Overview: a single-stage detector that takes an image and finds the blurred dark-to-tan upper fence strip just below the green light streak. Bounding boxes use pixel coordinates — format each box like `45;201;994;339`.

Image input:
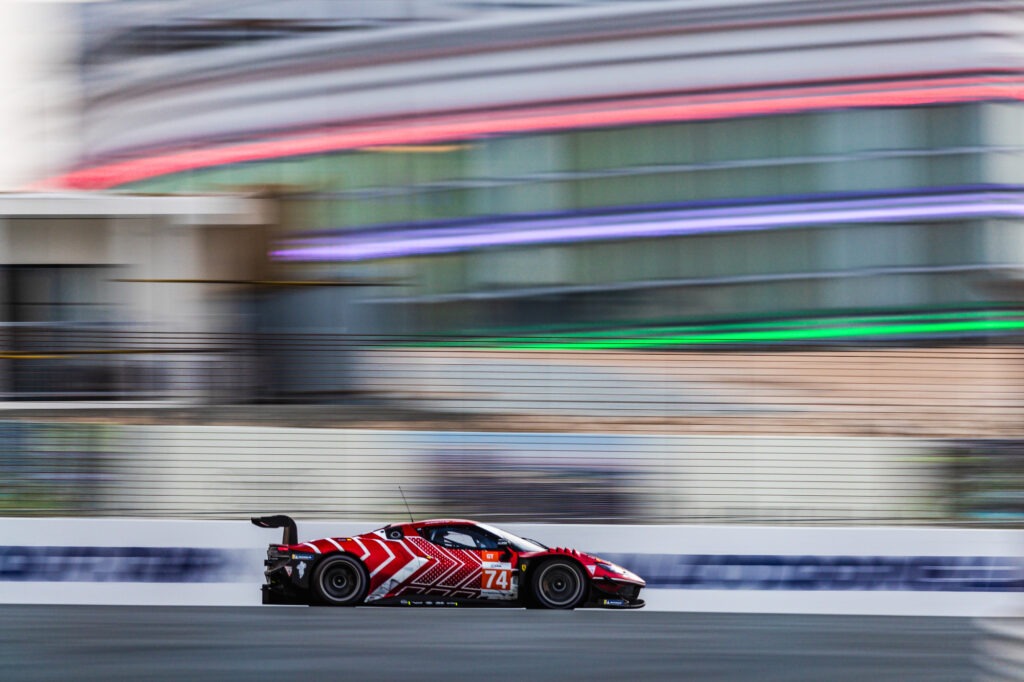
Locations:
0;330;1024;438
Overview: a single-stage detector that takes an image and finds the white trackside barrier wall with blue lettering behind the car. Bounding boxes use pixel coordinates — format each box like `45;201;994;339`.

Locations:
0;518;1024;616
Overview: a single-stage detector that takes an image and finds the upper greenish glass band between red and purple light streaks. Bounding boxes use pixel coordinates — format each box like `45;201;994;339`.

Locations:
124;103;987;223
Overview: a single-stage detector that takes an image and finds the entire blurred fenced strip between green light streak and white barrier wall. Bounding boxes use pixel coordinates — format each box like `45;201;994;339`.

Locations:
0;335;1024;524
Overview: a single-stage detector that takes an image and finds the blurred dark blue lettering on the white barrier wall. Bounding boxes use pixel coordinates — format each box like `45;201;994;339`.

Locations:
0;546;1024;592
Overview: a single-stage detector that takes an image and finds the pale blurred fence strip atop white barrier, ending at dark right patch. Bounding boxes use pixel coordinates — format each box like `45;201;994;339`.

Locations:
0;422;950;523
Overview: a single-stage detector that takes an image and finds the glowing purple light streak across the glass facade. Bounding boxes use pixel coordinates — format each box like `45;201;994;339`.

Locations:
271;191;1024;262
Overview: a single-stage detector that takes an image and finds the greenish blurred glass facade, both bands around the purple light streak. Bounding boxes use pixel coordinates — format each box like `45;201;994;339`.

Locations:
114;103;1024;332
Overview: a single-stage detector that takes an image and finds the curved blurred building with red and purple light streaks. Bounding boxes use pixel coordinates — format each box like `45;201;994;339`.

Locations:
48;0;1024;335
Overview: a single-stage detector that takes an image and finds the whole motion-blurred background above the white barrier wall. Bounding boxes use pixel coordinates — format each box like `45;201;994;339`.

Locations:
6;0;1024;525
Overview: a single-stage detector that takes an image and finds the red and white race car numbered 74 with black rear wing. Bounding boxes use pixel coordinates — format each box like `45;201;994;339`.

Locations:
252;515;645;608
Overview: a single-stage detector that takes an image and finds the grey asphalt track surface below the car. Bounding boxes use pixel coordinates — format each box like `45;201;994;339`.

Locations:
0;605;977;682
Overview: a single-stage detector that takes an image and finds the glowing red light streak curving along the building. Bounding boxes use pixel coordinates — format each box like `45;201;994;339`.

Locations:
36;77;1024;189
